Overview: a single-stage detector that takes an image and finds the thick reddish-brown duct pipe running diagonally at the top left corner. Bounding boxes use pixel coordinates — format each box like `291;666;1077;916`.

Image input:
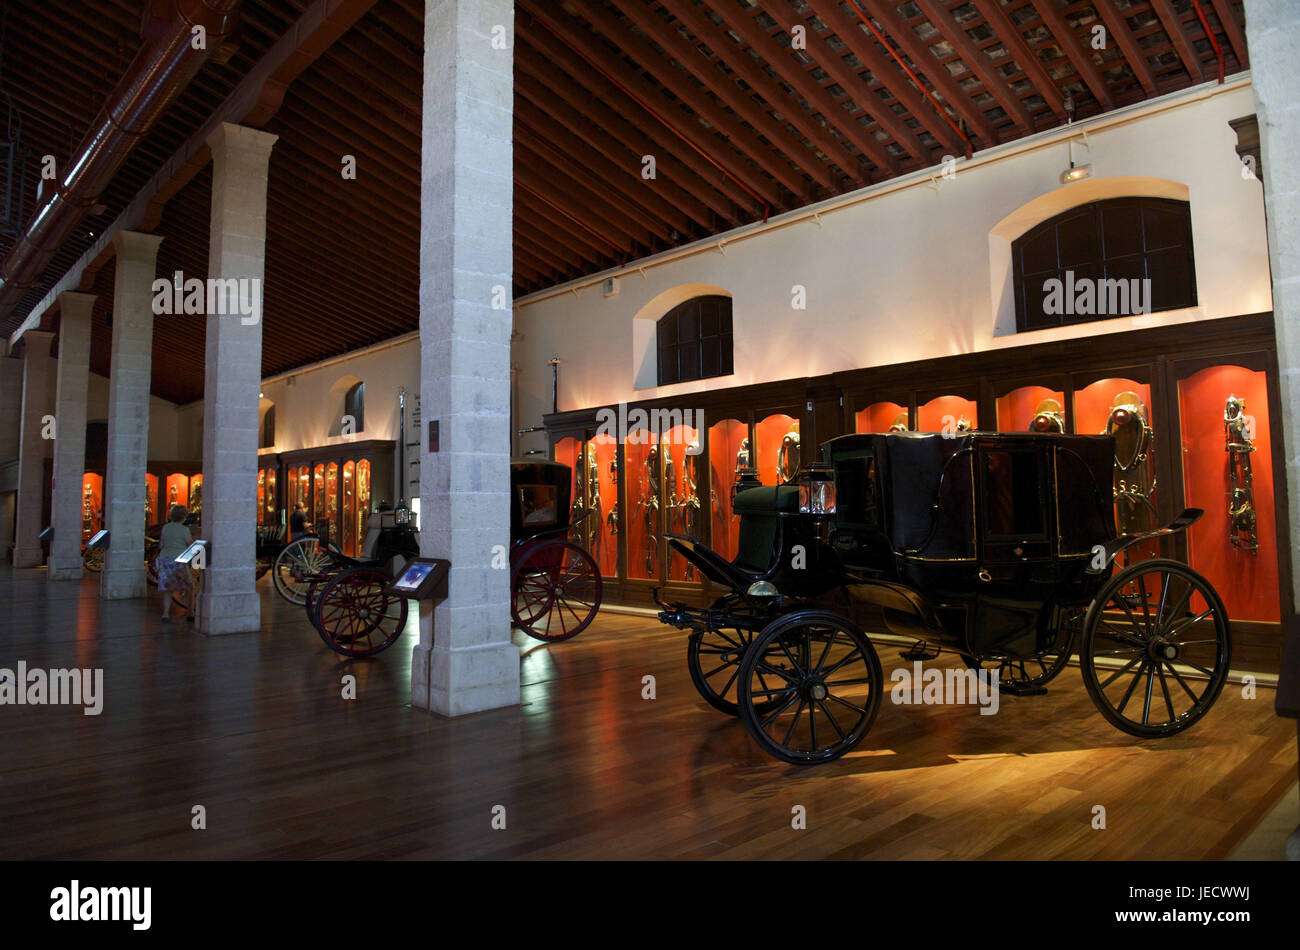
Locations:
0;0;241;318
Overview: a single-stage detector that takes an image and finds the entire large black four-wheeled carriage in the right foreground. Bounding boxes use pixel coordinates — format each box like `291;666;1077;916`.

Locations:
659;433;1231;764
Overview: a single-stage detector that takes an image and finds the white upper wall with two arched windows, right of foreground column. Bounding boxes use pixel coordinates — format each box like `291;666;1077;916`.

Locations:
514;79;1271;447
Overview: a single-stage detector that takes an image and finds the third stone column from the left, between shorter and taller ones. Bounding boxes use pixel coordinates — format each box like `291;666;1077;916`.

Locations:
99;231;162;600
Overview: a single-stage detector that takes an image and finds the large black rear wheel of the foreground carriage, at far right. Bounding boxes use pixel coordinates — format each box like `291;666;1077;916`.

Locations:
1079;560;1232;738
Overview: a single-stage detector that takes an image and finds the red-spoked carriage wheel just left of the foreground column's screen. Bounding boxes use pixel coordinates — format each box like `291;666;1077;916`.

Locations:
315;568;407;656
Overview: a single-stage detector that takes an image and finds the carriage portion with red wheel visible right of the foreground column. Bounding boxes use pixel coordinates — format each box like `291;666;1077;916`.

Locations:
510;459;602;642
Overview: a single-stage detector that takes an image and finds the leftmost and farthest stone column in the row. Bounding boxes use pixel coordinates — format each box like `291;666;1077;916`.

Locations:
13;330;55;568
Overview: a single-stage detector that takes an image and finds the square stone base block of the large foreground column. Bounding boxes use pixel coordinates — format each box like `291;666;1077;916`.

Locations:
411;641;519;716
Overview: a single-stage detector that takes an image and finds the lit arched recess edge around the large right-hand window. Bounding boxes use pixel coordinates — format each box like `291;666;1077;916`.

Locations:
988;175;1195;339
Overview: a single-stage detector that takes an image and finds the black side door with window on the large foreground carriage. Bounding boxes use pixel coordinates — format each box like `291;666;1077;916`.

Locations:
979;443;1065;581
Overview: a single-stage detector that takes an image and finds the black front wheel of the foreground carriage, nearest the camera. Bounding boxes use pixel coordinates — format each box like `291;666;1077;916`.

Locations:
737;611;884;765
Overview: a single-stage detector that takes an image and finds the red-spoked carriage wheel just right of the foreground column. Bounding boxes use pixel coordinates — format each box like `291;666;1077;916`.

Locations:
510;541;602;643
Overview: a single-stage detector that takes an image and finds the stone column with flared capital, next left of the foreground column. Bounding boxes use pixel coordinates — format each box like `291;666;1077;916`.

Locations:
199;122;277;634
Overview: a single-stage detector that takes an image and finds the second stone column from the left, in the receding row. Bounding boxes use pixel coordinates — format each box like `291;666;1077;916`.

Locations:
49;291;95;581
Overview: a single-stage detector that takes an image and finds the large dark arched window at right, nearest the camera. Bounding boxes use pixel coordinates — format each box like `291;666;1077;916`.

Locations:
1011;198;1196;331
